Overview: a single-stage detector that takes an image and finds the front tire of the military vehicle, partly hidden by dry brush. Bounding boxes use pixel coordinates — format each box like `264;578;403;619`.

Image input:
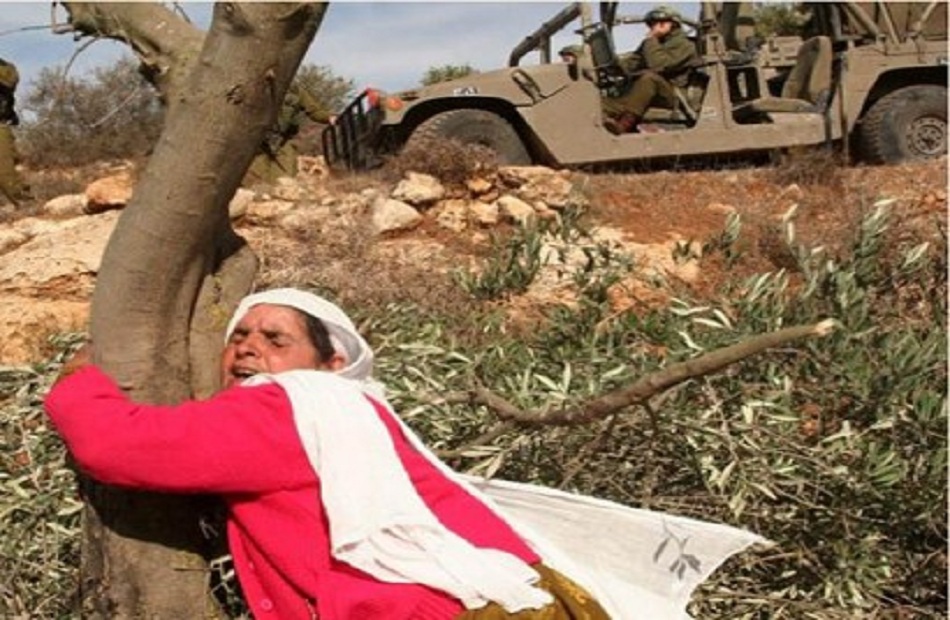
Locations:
409;110;531;166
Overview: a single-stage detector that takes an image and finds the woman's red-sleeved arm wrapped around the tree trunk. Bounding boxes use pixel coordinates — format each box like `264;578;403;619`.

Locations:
45;363;315;493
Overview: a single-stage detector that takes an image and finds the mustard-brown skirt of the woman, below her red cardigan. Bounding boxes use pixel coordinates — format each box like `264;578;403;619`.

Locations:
456;564;610;620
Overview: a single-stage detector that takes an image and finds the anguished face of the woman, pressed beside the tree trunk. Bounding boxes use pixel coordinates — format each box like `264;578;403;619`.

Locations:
221;304;339;388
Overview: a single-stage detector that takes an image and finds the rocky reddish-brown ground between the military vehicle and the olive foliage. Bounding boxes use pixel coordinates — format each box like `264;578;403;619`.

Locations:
0;155;947;366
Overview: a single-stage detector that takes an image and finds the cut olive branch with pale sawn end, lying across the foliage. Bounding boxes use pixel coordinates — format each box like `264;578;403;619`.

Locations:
442;319;835;432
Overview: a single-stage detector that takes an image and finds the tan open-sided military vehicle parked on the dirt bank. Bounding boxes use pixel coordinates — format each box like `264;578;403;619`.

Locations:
322;2;948;169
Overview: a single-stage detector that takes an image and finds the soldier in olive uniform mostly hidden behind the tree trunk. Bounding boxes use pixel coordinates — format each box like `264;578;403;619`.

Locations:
244;82;333;185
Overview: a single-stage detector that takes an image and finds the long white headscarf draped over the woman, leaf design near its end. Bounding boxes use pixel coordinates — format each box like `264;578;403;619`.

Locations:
227;289;766;620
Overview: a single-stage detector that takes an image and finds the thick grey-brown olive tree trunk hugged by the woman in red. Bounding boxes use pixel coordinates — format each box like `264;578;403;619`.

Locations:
57;3;327;619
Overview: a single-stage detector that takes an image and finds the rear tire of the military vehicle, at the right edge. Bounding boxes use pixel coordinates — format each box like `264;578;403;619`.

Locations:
859;85;947;164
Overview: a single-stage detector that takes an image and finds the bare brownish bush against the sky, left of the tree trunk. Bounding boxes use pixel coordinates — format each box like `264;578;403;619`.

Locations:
20;59;164;167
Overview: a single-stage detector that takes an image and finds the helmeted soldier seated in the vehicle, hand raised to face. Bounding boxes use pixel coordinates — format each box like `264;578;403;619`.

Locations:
603;6;699;134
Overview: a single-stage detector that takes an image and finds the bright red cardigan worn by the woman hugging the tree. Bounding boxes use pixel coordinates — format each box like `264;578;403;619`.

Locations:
45;366;538;620
